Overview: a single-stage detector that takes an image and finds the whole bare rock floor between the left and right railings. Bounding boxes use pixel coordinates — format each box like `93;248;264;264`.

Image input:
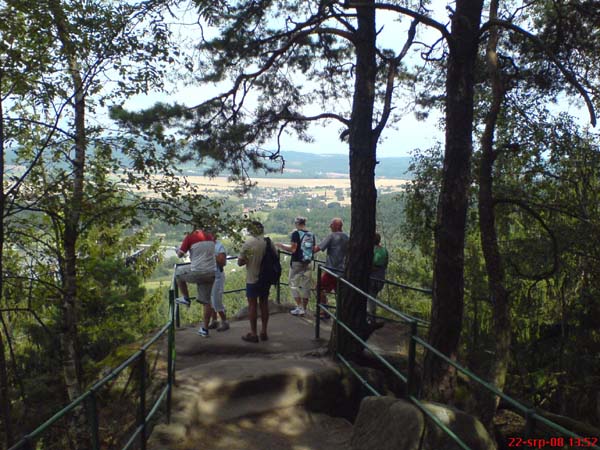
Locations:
148;305;352;450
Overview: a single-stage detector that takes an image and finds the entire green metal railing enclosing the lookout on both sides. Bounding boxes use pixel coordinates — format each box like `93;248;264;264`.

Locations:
14;251;600;450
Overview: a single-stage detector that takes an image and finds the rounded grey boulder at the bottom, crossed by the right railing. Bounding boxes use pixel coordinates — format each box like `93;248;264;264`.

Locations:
351;397;496;450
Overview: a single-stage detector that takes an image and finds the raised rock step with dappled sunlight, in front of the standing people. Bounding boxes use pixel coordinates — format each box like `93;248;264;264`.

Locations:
172;357;342;427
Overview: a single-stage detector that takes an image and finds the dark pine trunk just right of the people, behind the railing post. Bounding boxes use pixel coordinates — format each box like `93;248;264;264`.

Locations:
330;1;377;357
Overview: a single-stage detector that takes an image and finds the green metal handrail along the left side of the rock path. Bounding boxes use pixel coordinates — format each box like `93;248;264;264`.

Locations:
9;288;175;450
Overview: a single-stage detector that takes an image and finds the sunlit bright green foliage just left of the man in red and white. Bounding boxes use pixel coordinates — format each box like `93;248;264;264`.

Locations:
79;227;164;366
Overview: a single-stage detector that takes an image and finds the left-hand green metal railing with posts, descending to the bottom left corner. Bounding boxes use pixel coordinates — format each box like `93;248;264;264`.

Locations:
9;279;175;450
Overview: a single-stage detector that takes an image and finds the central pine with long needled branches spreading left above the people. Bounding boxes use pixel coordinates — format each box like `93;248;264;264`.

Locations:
116;0;417;355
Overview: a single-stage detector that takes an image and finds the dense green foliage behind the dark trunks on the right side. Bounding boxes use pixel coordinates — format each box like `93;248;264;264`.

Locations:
406;98;600;423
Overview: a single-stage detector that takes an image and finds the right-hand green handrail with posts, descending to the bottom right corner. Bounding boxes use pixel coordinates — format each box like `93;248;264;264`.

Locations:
315;265;600;450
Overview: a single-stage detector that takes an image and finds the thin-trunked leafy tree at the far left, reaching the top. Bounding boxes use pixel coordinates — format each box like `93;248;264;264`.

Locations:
0;0;185;443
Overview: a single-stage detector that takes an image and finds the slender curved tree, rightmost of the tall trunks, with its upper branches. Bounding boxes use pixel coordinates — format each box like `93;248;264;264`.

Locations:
478;2;595;425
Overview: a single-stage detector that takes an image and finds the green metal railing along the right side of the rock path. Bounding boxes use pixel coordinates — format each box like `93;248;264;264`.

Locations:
315;265;600;450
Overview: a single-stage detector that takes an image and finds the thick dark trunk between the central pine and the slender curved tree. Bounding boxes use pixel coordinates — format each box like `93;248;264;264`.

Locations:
424;0;483;400
